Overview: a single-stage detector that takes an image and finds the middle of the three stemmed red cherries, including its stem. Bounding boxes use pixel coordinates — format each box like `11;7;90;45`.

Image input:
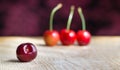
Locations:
60;6;76;45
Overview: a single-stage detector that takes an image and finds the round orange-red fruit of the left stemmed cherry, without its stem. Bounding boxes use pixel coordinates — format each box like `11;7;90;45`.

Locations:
43;30;60;46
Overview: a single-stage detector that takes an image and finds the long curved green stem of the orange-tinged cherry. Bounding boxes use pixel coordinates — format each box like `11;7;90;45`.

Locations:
49;3;62;31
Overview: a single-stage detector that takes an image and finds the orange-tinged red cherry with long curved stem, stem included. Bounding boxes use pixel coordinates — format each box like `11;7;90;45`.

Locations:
43;3;62;46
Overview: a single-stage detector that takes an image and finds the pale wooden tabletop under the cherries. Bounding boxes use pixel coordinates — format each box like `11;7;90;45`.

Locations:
0;36;120;70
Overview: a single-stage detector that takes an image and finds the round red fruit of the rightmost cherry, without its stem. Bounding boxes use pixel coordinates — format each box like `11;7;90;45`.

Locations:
77;30;91;46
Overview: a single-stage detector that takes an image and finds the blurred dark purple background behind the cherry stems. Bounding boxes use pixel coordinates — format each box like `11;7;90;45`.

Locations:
0;0;120;36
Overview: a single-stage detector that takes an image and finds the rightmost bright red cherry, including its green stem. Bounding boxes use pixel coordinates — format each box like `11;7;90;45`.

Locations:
77;7;91;45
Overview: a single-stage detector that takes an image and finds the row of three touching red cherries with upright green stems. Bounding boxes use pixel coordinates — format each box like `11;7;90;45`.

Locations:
43;3;91;46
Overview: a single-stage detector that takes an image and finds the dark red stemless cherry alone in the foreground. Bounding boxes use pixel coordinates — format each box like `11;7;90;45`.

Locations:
16;43;37;62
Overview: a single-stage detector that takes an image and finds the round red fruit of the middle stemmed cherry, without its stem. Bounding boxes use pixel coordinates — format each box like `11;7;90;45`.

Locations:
60;29;76;45
